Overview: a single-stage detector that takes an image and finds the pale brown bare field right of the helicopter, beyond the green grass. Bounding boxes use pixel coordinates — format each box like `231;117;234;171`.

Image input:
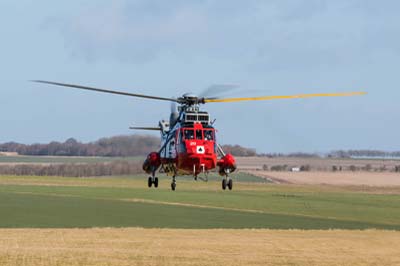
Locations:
237;157;400;187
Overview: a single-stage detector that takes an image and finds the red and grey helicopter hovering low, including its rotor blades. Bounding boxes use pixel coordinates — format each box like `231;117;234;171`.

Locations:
33;80;366;190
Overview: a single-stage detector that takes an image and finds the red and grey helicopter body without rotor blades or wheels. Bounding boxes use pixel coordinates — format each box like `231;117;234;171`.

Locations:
143;108;236;180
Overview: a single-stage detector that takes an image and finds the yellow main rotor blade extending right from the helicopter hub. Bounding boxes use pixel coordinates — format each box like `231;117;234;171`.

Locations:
204;92;367;103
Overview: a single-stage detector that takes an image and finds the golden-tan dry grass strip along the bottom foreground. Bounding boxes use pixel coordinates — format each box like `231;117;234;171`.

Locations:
0;228;400;266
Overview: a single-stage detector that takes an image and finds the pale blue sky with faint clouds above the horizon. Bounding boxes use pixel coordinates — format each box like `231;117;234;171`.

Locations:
0;0;400;152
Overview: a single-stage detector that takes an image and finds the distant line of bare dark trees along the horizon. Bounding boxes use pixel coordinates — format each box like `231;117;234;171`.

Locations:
0;135;400;158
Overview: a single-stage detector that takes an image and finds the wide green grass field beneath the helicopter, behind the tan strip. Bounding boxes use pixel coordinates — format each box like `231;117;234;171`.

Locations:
0;175;400;230
